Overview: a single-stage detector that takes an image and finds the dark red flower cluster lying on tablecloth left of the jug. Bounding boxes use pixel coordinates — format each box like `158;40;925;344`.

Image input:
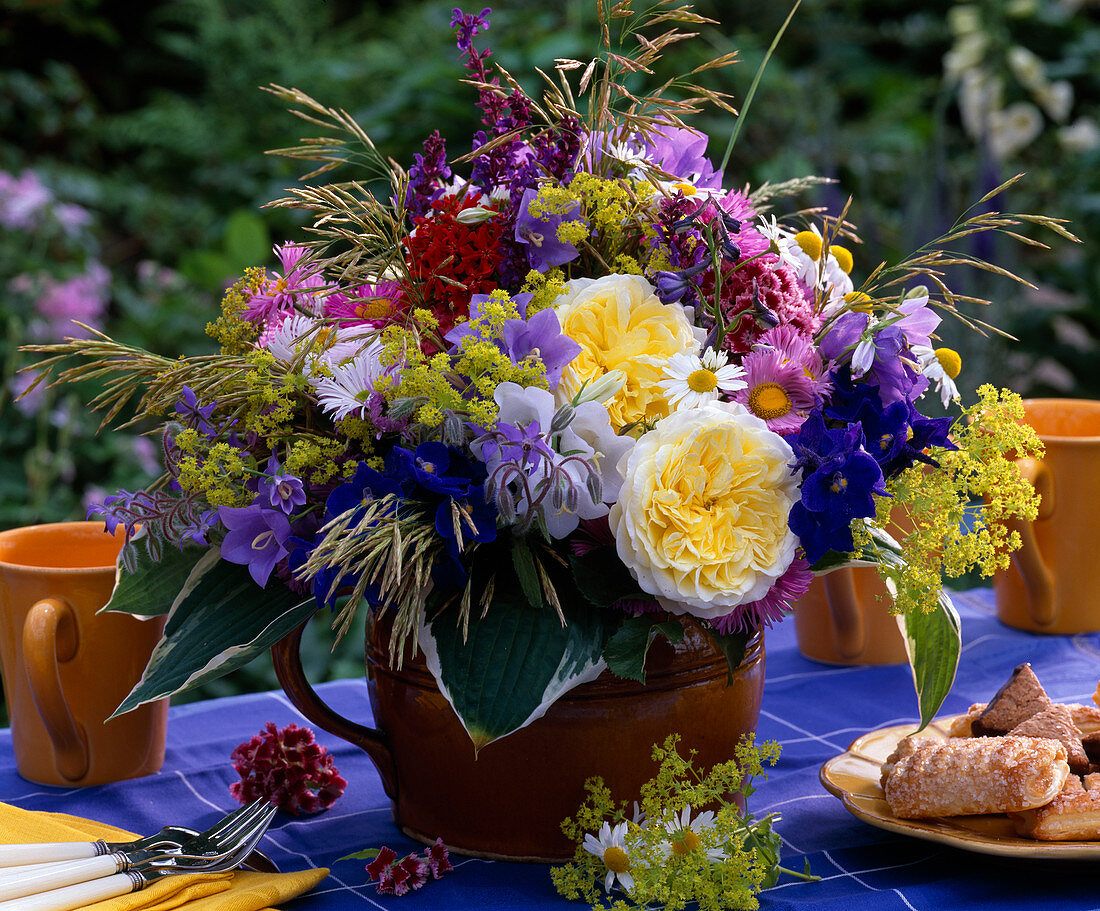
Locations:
229;722;348;816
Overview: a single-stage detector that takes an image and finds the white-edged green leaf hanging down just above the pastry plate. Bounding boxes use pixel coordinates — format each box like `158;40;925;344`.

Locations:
887;581;963;731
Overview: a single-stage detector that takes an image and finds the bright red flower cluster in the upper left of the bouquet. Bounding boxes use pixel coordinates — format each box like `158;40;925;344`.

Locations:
405;194;504;334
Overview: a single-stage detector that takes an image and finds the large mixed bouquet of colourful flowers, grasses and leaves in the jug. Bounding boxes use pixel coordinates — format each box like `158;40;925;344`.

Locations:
30;2;1066;862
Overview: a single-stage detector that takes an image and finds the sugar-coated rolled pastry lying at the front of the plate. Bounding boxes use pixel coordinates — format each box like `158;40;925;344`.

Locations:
881;737;1069;820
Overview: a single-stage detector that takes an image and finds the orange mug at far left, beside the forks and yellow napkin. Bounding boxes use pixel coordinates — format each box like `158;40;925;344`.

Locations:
0;522;168;787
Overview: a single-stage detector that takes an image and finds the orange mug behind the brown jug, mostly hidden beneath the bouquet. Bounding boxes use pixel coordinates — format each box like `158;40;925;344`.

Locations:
794;567;908;665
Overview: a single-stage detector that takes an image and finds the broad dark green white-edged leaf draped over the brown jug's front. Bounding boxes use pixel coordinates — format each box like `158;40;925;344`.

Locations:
420;585;605;750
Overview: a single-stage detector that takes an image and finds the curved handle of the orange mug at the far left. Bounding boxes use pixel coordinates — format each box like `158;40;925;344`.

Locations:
23;597;90;781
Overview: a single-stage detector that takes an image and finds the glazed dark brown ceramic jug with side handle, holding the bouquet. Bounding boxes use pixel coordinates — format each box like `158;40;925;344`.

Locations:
273;623;765;861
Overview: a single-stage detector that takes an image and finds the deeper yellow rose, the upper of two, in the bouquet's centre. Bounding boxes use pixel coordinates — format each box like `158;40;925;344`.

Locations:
556;275;702;430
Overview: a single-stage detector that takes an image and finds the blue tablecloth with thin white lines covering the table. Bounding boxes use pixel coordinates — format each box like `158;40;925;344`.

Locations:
0;590;1100;911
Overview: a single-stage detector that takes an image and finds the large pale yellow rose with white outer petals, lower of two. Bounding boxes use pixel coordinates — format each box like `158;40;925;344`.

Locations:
608;403;799;618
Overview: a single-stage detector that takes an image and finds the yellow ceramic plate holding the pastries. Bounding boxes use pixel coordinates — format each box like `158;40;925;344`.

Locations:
821;716;1100;860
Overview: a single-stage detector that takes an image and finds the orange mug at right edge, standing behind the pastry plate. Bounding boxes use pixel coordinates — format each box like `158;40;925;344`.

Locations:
993;398;1100;634
